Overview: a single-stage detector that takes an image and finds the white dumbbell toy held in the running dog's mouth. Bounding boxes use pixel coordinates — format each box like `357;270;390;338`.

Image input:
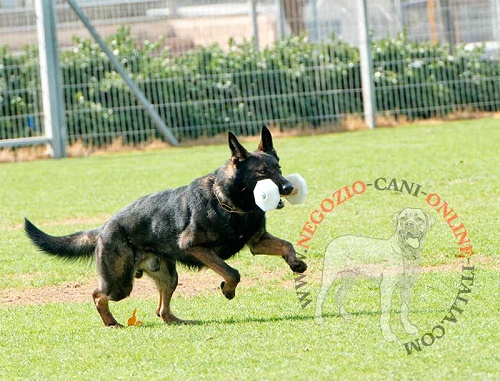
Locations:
253;173;307;212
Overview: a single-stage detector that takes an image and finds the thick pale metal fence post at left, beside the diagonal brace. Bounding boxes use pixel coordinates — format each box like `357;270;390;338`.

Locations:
35;0;66;158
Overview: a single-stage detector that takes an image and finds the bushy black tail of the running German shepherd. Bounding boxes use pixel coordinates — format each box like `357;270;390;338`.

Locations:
24;218;100;260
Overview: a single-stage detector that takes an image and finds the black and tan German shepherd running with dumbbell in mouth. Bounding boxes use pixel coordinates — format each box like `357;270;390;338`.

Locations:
25;126;307;327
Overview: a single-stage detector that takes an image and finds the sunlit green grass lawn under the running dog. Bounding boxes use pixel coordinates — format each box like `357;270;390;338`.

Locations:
0;119;500;380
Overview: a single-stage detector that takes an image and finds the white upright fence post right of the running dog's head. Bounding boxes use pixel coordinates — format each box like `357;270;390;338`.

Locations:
357;0;376;128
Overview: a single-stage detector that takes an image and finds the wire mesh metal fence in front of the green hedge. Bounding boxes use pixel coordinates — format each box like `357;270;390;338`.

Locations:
0;0;500;154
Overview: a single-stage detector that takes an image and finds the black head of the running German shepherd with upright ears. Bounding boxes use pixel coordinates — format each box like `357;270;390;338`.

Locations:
228;126;293;208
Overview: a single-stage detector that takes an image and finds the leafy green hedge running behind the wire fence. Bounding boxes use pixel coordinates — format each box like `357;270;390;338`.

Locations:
0;27;500;145
